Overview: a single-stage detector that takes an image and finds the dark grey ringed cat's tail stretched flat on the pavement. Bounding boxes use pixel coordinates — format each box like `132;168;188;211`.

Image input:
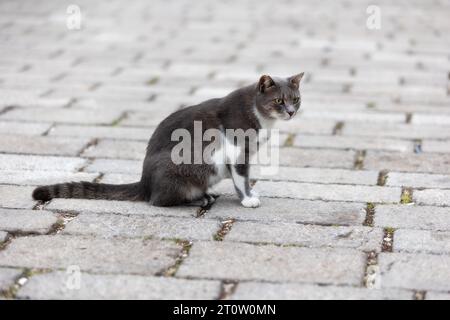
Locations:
33;181;145;201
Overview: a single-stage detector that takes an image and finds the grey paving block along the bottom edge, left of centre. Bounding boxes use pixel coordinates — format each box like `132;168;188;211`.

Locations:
17;272;220;300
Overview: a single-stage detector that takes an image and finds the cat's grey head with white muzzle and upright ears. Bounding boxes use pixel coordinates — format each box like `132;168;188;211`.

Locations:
256;72;304;120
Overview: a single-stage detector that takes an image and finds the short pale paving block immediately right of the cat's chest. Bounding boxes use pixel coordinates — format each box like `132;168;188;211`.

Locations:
279;148;356;169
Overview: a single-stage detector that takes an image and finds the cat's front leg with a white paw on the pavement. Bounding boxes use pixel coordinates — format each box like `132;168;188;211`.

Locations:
230;164;261;208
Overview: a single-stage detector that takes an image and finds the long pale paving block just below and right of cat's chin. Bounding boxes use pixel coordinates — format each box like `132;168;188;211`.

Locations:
294;135;414;152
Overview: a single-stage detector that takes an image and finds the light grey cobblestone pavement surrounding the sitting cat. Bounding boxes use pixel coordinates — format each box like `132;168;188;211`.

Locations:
0;0;450;299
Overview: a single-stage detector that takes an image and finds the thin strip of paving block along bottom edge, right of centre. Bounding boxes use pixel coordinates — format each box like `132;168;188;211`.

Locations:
231;282;413;300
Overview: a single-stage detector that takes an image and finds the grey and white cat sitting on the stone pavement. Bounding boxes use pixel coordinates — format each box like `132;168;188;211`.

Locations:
32;72;304;208
